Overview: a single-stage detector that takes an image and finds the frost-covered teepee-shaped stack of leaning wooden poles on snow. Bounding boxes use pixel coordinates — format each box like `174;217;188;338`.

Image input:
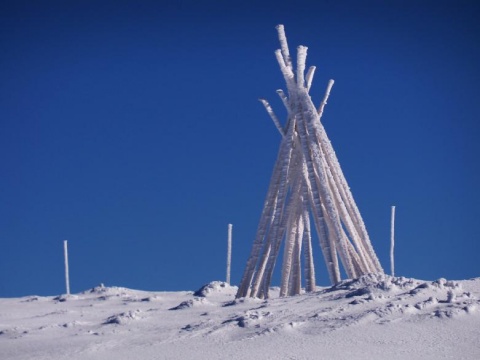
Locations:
237;25;383;298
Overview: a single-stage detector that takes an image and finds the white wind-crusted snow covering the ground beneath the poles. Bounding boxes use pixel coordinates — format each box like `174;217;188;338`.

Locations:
0;275;480;360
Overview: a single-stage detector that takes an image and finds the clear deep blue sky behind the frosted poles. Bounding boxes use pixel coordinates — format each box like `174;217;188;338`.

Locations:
0;1;480;297
